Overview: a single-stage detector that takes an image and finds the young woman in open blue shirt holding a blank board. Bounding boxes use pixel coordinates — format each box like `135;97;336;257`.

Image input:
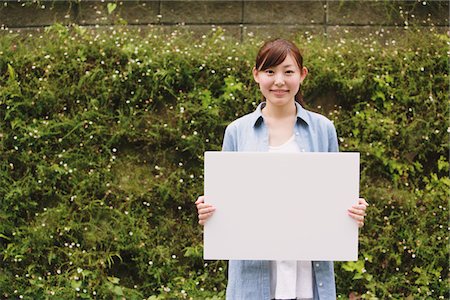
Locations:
195;39;368;300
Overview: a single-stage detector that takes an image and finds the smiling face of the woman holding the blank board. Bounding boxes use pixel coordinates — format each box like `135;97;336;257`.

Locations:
253;54;308;106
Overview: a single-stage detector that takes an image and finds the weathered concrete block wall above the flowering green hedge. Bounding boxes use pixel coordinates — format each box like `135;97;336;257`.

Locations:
0;0;449;40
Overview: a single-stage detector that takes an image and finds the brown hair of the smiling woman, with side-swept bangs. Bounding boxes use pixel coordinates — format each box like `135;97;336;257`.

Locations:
255;39;305;107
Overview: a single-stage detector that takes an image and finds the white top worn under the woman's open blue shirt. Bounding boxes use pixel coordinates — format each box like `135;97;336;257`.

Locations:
269;135;313;299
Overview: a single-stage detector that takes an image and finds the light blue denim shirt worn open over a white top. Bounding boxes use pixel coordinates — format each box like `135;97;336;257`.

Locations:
222;102;338;300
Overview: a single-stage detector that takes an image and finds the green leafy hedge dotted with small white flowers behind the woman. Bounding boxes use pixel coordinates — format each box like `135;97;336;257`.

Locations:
0;25;450;299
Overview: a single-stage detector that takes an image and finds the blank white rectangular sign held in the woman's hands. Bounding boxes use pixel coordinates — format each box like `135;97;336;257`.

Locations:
204;151;359;261
